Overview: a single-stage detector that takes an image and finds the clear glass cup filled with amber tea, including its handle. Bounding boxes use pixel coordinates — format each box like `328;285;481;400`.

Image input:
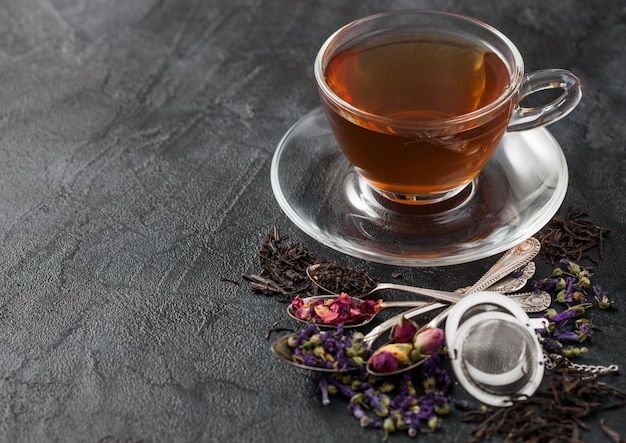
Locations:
314;10;582;205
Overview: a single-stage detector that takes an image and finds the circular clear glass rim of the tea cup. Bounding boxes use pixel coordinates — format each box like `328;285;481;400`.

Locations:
314;9;524;131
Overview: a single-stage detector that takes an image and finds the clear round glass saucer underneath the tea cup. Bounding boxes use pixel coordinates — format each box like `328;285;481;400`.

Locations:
271;108;568;267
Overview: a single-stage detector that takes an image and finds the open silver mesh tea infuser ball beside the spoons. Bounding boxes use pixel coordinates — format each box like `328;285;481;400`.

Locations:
445;292;547;406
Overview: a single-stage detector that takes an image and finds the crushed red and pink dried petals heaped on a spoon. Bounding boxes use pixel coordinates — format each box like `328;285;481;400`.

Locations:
291;292;383;326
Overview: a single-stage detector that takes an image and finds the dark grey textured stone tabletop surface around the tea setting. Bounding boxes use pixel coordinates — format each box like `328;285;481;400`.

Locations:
0;0;626;442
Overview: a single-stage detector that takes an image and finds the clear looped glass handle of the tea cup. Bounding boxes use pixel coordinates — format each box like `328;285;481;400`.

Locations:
507;69;583;132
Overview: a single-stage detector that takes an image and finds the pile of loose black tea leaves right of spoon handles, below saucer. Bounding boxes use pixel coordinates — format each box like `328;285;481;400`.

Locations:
537;208;609;265
